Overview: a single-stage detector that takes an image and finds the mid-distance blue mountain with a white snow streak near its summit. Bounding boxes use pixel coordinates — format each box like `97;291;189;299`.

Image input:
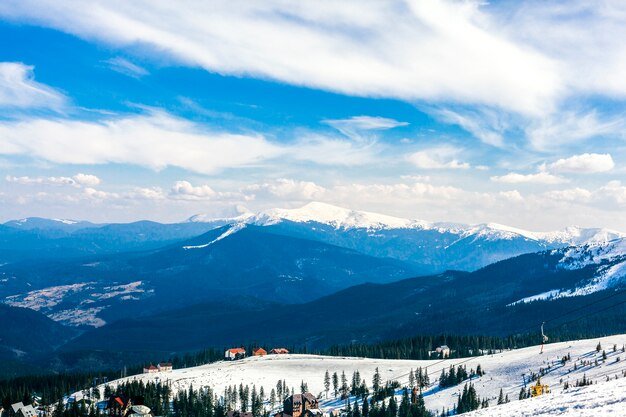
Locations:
0;225;419;326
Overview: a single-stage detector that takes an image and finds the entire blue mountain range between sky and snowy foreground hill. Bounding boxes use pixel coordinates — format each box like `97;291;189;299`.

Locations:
0;203;626;370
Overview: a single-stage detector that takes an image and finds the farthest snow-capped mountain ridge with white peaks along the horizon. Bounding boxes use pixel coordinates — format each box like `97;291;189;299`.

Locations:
191;202;626;273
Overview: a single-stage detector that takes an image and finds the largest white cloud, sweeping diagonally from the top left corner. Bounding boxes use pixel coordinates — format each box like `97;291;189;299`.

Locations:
0;0;561;114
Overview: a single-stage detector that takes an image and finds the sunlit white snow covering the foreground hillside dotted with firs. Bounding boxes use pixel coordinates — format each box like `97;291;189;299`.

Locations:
86;329;626;416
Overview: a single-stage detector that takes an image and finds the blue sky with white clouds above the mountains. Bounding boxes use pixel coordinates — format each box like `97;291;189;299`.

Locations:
0;0;626;231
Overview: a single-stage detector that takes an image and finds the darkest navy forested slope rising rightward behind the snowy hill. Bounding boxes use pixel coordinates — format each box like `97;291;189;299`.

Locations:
64;239;626;351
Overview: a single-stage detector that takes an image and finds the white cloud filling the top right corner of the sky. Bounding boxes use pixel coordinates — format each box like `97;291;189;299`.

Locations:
500;0;626;98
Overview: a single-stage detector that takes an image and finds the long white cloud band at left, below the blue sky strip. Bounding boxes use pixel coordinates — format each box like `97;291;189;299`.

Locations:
0;112;286;173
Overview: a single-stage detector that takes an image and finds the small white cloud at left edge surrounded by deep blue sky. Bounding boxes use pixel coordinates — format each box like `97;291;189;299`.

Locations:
0;62;66;110
